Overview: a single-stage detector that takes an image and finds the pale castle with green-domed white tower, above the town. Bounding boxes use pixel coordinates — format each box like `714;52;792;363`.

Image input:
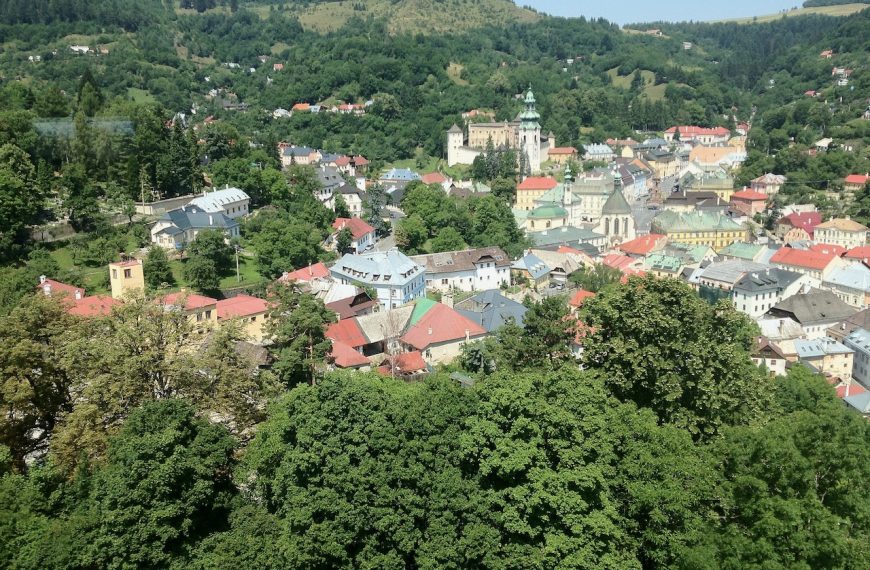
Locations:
447;87;556;175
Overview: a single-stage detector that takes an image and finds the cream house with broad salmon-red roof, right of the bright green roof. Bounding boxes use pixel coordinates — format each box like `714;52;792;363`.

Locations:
400;303;487;364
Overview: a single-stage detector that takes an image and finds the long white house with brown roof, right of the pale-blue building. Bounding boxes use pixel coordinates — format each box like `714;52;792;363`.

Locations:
411;246;511;293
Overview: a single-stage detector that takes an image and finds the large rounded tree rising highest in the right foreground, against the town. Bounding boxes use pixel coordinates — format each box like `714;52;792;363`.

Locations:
581;277;771;439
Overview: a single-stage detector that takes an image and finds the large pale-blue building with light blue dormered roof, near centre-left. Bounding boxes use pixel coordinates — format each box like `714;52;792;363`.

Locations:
329;249;426;310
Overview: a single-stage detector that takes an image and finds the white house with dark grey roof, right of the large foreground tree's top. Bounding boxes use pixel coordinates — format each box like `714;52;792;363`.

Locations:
731;267;811;319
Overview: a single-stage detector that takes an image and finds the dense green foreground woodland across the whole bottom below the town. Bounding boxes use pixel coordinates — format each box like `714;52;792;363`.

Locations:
0;277;870;569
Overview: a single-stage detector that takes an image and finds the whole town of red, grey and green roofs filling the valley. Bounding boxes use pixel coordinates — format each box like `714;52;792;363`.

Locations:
30;85;870;415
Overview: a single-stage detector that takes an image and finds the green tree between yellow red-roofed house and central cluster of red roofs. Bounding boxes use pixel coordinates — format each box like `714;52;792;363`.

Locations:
266;285;335;387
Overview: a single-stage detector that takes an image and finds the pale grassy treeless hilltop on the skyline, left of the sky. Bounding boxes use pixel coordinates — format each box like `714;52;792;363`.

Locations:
242;0;541;34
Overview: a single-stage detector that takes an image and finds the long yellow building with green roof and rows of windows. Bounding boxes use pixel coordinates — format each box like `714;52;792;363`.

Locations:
651;210;747;251
